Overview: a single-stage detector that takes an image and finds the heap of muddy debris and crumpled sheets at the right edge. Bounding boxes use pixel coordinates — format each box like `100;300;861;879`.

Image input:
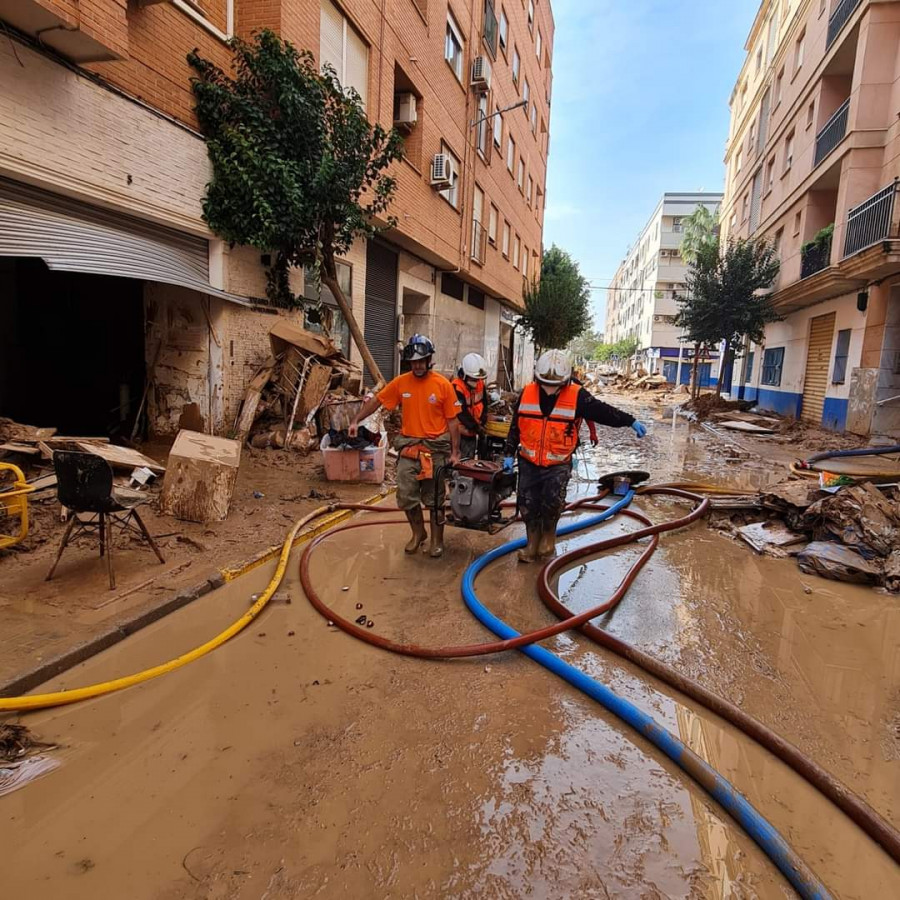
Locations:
709;479;900;593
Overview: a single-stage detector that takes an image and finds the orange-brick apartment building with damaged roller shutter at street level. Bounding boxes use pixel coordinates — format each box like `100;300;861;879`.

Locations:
0;0;554;434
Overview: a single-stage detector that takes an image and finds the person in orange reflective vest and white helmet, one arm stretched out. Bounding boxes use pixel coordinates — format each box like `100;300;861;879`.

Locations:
503;350;647;562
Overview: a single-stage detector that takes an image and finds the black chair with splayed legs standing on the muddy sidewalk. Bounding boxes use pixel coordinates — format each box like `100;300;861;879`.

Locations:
47;450;165;590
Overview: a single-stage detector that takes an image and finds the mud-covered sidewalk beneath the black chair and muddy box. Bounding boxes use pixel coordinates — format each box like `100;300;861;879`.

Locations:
0;448;381;696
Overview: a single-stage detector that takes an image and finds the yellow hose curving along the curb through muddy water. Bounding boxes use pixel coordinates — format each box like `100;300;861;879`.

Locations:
0;506;334;712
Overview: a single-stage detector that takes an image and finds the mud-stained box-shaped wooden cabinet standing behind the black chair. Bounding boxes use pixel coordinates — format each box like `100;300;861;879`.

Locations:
160;431;241;522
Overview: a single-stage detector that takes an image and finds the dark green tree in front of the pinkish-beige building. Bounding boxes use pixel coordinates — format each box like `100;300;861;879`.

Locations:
676;238;783;393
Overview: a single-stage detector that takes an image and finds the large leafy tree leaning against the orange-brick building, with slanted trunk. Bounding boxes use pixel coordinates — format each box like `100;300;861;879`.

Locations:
188;30;401;381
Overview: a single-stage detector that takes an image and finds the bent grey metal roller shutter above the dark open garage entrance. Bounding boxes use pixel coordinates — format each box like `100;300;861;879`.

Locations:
0;179;252;306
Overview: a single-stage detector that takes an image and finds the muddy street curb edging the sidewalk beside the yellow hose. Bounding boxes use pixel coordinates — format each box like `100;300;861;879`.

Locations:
0;490;393;697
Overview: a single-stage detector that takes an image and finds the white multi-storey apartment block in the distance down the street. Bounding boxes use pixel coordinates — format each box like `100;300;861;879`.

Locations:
605;193;722;386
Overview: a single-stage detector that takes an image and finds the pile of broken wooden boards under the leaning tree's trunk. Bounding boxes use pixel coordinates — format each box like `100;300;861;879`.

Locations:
233;322;363;454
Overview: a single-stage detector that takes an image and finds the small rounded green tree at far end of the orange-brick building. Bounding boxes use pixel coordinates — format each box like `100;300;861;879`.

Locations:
517;250;591;351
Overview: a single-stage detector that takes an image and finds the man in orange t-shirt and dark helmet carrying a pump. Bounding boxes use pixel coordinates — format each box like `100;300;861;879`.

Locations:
348;334;461;558
